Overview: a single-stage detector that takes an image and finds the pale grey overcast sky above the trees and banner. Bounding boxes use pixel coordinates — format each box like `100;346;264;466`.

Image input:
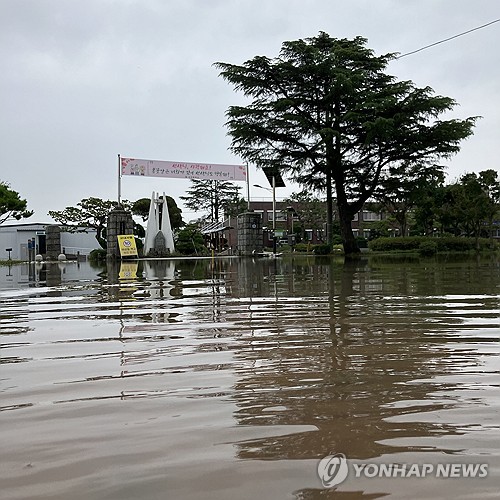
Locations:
0;0;500;222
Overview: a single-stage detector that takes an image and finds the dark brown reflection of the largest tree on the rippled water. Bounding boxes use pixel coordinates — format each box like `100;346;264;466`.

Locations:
230;261;477;459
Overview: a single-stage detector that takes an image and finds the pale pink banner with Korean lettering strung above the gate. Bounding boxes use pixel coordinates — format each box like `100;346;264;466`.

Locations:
121;158;247;181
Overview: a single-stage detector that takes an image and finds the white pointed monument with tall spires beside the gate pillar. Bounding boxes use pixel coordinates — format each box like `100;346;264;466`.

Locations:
144;191;175;256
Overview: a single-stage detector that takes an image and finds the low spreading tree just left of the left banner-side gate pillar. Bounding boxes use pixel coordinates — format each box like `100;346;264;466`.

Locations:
49;197;130;248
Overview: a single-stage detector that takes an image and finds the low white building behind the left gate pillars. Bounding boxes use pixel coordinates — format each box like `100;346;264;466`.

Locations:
0;222;99;260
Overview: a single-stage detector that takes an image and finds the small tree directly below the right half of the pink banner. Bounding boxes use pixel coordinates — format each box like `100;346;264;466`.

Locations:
181;179;241;222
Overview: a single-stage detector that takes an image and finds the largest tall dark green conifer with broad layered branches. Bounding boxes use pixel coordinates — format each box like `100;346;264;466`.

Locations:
215;32;475;254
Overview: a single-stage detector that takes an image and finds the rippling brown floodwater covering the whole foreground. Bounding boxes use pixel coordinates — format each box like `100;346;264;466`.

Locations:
0;256;500;500
